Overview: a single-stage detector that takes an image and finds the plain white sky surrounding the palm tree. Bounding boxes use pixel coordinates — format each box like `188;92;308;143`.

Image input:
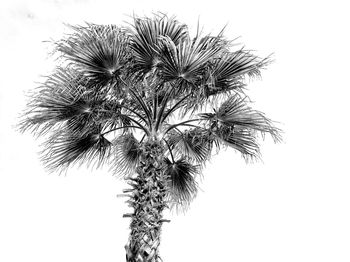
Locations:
0;0;350;262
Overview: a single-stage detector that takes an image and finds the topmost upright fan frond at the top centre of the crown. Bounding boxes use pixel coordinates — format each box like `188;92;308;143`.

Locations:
131;14;188;74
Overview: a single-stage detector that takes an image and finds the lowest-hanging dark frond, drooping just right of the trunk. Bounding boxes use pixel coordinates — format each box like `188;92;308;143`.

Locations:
165;158;199;208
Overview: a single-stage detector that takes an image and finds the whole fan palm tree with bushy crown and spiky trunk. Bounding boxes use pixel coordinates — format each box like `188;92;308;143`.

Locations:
19;14;281;262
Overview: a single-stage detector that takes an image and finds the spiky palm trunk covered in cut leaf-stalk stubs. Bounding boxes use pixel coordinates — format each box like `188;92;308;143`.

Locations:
125;141;166;262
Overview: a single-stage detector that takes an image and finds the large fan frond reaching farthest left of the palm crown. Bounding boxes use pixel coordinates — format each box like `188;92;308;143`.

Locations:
19;68;98;135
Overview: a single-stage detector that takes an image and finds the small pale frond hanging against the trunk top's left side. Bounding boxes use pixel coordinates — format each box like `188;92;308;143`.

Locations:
111;133;141;176
